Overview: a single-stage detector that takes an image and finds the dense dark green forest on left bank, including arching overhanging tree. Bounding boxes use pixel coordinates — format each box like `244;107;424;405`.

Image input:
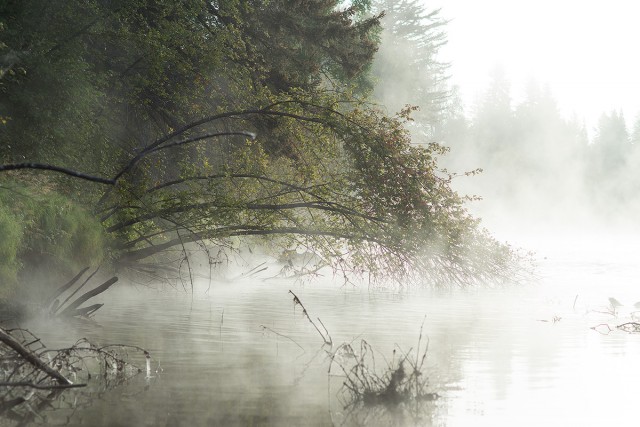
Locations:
0;0;515;304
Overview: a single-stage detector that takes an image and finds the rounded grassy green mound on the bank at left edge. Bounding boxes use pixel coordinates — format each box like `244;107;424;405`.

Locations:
0;178;108;299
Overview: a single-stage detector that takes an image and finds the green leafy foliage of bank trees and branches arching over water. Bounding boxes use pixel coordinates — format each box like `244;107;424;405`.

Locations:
0;0;520;283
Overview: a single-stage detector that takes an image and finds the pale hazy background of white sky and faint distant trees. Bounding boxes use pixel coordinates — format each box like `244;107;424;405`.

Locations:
400;0;640;237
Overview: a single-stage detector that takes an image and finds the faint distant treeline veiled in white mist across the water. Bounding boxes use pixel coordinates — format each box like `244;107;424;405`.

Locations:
439;75;640;237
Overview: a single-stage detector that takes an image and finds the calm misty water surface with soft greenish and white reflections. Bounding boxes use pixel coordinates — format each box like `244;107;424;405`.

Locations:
18;239;640;426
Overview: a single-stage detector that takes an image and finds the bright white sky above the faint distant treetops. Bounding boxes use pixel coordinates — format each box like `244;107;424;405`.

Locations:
430;0;640;131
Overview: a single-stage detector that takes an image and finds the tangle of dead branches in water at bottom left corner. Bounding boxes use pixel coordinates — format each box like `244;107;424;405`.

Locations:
0;329;150;425
